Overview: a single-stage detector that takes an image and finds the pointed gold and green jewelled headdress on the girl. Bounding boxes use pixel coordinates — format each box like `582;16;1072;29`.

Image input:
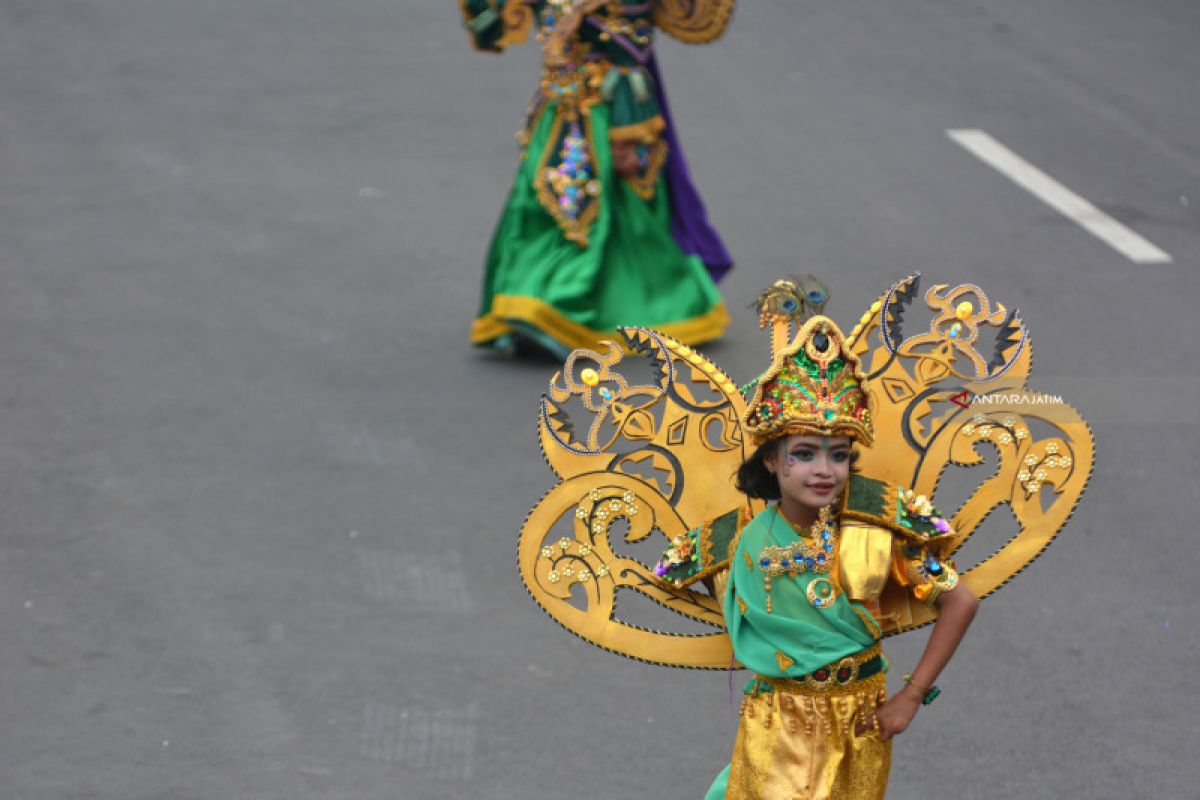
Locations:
742;317;875;445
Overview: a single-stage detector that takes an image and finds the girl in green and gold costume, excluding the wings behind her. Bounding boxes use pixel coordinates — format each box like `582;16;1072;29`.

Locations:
700;317;978;800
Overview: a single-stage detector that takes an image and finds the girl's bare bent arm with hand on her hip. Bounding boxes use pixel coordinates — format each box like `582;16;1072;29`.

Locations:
859;583;979;741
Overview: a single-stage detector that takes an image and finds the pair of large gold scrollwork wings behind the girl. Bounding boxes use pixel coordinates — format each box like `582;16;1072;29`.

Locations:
518;276;1093;669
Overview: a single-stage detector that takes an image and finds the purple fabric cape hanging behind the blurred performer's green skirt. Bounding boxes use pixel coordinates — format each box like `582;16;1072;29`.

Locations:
646;55;733;281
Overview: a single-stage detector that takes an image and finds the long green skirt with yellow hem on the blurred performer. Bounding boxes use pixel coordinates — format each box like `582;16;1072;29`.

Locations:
470;102;728;356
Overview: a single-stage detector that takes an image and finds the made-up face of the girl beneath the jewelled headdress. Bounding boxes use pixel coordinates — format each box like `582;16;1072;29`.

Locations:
763;434;851;516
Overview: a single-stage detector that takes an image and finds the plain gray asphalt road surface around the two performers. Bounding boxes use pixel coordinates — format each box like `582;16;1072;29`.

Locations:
0;0;1200;800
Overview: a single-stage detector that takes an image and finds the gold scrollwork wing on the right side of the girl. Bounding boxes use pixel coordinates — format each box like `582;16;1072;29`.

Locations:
848;275;1094;633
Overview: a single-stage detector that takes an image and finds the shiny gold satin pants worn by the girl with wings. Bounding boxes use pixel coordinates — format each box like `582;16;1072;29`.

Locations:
725;673;892;800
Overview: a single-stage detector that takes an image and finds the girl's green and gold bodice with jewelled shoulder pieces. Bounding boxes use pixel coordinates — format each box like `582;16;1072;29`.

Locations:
655;475;958;678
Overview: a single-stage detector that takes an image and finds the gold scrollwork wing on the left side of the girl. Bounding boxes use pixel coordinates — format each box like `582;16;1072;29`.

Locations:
521;329;746;668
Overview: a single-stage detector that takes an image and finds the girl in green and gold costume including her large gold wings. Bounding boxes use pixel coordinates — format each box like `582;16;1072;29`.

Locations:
517;275;1094;800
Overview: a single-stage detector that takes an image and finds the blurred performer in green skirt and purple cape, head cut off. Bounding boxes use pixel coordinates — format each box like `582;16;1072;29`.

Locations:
460;0;734;356
